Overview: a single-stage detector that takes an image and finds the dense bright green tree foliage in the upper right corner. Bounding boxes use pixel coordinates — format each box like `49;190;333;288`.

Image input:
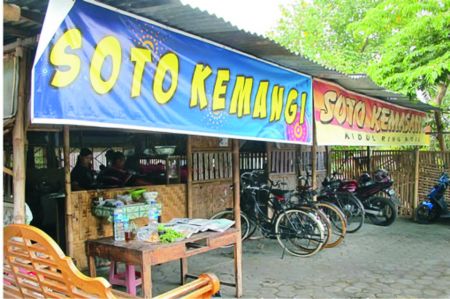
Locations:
347;0;450;95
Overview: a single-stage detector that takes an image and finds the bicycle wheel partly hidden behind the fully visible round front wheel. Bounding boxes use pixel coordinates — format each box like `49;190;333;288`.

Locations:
316;202;347;248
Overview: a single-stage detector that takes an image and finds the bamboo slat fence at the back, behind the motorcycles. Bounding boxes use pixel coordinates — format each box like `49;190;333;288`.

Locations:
330;150;450;216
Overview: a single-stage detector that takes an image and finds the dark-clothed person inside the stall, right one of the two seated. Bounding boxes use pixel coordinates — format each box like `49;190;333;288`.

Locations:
99;152;148;187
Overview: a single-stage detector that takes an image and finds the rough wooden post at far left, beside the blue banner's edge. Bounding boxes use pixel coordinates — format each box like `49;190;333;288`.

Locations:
12;47;27;223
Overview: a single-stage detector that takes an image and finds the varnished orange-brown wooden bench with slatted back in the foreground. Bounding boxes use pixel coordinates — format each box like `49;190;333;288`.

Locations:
3;224;220;299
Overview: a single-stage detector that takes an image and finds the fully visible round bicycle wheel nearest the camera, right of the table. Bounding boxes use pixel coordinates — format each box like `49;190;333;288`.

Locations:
275;209;324;257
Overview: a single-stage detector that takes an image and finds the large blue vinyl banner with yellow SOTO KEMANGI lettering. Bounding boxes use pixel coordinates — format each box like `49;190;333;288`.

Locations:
32;0;312;144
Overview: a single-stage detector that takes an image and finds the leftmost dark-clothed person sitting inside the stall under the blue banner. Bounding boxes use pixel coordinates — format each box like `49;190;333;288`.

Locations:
70;148;96;191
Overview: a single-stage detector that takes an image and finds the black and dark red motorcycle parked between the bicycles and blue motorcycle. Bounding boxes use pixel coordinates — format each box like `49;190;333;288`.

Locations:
326;169;400;226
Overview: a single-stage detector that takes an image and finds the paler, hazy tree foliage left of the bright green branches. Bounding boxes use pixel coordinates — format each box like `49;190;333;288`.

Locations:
269;0;381;73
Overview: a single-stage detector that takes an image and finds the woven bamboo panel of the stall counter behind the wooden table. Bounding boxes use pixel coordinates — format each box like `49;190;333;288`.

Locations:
71;184;186;269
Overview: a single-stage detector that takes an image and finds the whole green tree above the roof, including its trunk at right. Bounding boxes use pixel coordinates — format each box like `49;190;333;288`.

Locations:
270;0;450;150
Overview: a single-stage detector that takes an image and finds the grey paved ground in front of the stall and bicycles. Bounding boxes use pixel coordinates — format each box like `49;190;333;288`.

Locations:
98;219;450;298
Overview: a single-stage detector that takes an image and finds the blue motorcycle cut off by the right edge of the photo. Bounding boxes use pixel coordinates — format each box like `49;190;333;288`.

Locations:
416;172;450;224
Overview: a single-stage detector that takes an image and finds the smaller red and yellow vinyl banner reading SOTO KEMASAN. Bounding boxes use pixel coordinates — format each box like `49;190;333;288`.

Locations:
313;80;428;146
